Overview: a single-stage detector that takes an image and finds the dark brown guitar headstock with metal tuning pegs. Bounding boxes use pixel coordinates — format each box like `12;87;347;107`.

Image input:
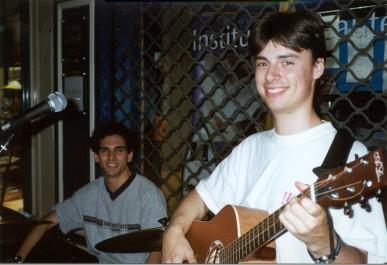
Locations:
315;148;387;211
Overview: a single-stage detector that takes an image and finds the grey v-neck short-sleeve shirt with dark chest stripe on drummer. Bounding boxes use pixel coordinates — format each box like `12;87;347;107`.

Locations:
55;174;167;263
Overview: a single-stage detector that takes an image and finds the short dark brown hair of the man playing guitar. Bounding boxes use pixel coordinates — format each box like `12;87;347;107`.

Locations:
249;11;326;60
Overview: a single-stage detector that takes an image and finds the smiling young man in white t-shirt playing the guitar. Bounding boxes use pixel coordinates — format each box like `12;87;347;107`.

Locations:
163;9;387;264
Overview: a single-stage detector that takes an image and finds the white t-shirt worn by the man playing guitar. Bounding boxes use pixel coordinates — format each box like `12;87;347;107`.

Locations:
196;123;387;263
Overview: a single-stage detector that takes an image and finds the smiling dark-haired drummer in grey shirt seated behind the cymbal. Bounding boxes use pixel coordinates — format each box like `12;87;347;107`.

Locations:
15;123;167;263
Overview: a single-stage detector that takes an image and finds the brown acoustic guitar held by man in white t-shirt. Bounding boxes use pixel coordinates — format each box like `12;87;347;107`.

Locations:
186;148;387;263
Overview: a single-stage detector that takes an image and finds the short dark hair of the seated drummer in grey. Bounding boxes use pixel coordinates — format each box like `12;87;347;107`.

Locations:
90;122;139;154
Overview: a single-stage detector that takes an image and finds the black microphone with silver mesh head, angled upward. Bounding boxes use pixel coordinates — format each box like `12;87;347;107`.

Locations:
1;91;67;132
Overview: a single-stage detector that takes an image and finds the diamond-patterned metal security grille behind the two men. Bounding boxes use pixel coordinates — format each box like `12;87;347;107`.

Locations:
104;0;387;211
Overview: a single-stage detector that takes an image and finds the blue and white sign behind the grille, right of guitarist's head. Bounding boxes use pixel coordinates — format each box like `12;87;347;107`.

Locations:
321;7;387;92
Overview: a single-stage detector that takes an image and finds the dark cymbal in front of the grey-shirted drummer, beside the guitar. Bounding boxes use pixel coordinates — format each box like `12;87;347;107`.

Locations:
95;227;165;253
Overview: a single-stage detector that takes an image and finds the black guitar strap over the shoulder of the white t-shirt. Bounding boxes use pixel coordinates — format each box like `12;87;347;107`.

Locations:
313;129;355;176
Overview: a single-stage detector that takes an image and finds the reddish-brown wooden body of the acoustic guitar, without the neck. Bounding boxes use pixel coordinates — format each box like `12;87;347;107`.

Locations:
186;205;275;263
